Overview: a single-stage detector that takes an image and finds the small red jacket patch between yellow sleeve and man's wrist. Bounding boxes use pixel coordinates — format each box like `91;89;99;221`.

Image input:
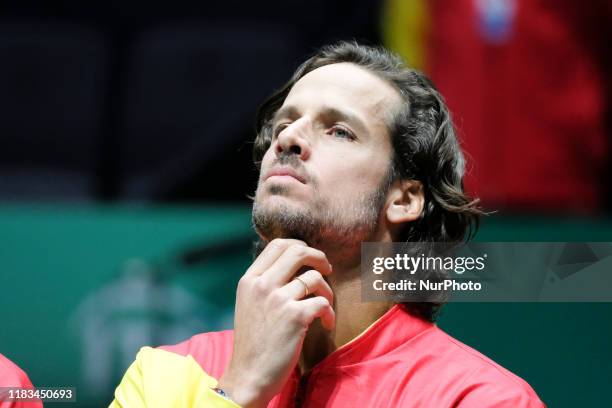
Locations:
159;330;234;378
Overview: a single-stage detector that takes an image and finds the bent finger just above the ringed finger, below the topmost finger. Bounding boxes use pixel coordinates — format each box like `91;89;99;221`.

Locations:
259;245;332;287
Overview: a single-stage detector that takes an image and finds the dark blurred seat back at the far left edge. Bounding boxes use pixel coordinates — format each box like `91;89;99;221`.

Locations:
0;22;110;201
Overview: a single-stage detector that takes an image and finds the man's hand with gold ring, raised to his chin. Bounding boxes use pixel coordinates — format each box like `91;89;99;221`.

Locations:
219;239;335;407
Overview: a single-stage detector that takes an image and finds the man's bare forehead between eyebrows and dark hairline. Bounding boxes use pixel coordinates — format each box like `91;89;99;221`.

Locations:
283;62;401;122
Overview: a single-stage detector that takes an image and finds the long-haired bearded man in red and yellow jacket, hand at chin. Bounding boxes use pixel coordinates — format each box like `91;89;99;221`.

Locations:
111;43;543;407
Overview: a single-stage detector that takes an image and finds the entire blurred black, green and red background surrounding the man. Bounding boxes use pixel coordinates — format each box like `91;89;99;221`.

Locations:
0;0;612;407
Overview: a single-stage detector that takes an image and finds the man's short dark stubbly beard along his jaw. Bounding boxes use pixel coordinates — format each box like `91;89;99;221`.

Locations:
252;161;394;256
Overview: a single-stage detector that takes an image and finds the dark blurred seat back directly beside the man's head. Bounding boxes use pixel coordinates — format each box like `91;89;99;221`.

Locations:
118;21;297;199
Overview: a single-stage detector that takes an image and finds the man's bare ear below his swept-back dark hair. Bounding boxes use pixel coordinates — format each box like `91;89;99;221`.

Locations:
387;180;425;224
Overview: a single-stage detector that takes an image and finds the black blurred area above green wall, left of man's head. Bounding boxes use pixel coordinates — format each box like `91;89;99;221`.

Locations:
0;0;380;203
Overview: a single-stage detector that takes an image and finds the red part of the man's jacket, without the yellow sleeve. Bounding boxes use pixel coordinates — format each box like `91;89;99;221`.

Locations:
162;305;544;408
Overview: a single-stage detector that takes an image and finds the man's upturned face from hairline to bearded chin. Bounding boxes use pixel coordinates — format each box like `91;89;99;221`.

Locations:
253;63;401;246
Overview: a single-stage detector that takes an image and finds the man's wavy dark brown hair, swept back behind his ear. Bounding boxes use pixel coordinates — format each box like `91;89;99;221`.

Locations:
253;41;483;321
